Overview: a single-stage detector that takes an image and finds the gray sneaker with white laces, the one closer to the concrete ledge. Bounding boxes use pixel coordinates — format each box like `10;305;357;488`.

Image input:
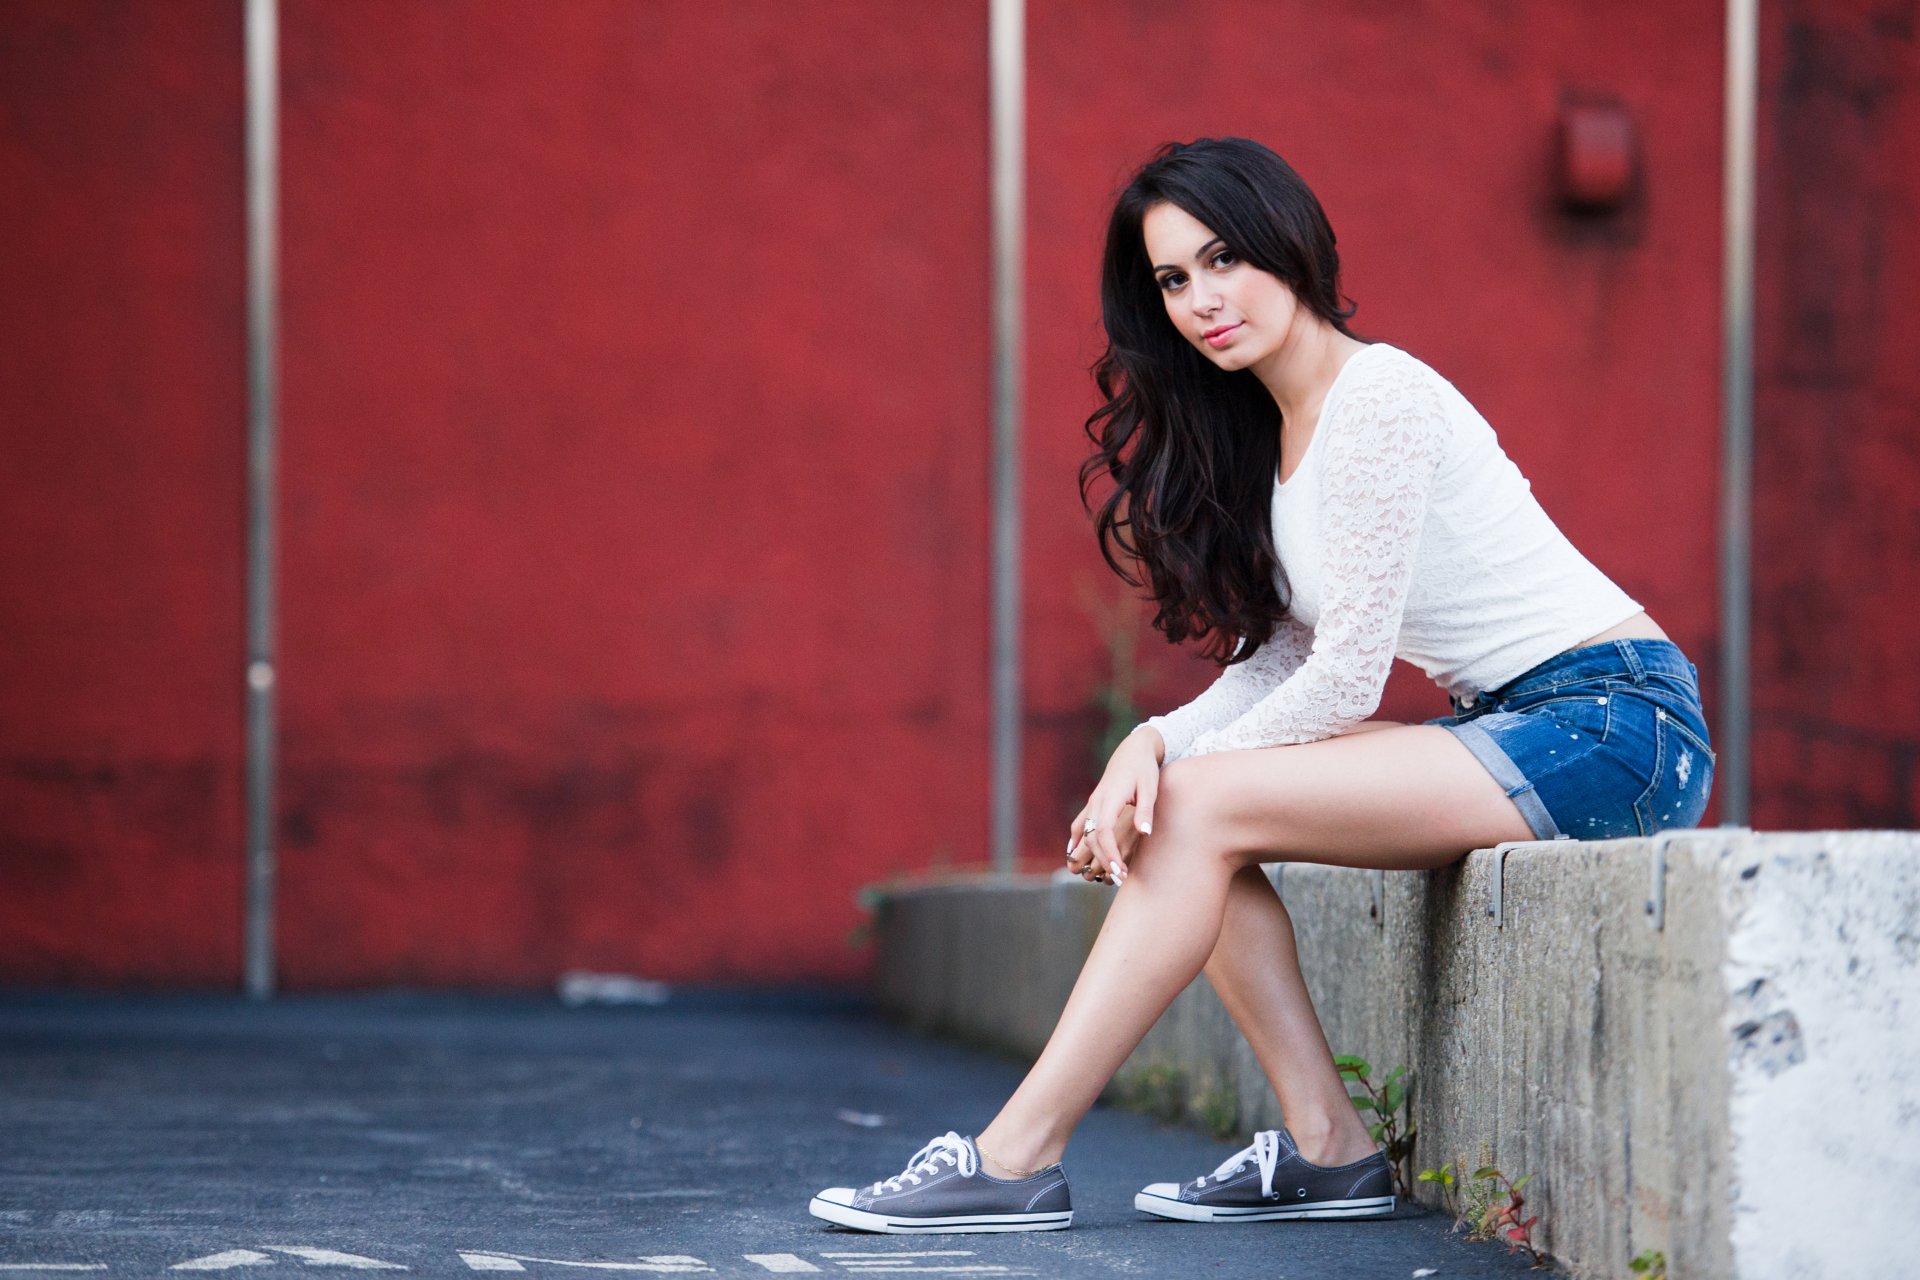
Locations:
1133;1128;1394;1222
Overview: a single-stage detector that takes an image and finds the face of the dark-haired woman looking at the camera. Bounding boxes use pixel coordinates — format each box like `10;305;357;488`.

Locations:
1140;201;1302;368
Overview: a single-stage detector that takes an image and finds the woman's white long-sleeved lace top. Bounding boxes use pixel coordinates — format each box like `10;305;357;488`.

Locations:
1146;344;1640;760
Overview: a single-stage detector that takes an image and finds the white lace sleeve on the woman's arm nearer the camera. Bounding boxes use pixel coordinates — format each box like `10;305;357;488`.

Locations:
1187;359;1448;756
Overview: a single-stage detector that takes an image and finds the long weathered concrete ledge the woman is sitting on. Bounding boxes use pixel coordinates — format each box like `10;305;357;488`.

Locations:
877;829;1920;1280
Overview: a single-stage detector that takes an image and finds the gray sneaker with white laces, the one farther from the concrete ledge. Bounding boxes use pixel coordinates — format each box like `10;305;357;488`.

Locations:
808;1132;1073;1234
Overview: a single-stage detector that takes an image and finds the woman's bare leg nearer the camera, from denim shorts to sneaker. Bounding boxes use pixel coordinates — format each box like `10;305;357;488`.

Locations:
979;725;1532;1173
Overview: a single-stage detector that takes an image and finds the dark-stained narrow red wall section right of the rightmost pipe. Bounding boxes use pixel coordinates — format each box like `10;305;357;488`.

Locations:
1753;0;1920;829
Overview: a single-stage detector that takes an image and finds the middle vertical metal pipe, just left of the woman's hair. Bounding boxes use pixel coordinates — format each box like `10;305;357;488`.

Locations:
987;0;1027;873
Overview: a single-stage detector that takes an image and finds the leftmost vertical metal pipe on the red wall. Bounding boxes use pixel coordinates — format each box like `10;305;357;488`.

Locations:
246;0;280;1000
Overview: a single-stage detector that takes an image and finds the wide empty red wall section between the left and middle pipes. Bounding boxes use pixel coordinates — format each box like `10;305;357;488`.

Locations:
280;0;987;986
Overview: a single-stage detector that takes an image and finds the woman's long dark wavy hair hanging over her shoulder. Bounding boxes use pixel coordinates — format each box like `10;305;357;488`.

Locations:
1079;138;1354;666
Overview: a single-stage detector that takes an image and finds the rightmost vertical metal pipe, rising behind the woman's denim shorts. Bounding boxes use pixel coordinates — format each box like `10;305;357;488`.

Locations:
1715;0;1761;827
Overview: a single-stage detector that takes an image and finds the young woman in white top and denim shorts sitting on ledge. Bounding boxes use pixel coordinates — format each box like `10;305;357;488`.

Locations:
812;138;1715;1232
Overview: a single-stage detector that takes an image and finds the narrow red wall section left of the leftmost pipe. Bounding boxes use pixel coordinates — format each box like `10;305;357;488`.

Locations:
0;0;246;983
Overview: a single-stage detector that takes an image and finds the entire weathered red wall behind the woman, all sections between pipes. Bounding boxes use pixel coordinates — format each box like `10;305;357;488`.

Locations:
0;0;1920;988
